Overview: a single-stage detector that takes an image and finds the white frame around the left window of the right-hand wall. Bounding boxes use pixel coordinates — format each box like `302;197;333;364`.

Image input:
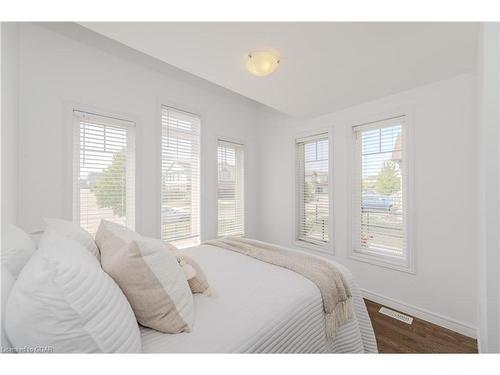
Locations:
291;128;335;256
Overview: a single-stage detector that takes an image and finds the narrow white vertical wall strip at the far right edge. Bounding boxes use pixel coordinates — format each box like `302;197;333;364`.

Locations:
477;23;500;353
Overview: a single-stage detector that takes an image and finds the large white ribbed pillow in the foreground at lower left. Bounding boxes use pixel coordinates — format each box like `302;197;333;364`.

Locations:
5;238;141;353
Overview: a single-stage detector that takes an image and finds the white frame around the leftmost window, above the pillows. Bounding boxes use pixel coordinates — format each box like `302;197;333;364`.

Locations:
71;107;137;235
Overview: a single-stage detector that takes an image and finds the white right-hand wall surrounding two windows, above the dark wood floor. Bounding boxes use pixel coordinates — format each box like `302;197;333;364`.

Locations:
258;74;477;335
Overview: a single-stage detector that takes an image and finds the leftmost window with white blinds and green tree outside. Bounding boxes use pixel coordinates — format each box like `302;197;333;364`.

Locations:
73;110;135;234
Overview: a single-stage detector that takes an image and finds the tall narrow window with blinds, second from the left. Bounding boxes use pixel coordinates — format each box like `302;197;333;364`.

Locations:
161;106;200;247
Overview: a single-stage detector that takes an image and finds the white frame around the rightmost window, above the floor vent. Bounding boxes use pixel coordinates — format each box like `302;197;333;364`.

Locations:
347;108;415;274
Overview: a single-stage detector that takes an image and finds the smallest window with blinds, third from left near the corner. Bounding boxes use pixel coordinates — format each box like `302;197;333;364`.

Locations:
217;140;245;236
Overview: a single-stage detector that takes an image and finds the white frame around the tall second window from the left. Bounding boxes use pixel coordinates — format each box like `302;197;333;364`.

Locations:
157;104;200;248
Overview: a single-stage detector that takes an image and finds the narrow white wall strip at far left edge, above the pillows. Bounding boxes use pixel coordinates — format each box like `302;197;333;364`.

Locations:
1;22;19;229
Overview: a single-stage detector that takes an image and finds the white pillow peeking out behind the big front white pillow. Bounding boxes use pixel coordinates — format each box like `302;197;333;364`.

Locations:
38;219;101;260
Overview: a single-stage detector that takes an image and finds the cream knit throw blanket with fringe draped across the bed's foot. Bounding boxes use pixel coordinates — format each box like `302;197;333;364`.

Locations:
205;237;353;339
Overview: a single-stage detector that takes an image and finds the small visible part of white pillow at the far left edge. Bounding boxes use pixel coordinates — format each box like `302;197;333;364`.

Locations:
2;224;36;279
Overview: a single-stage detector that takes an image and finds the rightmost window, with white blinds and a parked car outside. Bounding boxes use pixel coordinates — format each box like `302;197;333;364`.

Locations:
352;116;409;269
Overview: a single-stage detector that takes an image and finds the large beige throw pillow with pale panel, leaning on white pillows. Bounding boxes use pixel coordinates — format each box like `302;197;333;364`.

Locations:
96;220;194;333
